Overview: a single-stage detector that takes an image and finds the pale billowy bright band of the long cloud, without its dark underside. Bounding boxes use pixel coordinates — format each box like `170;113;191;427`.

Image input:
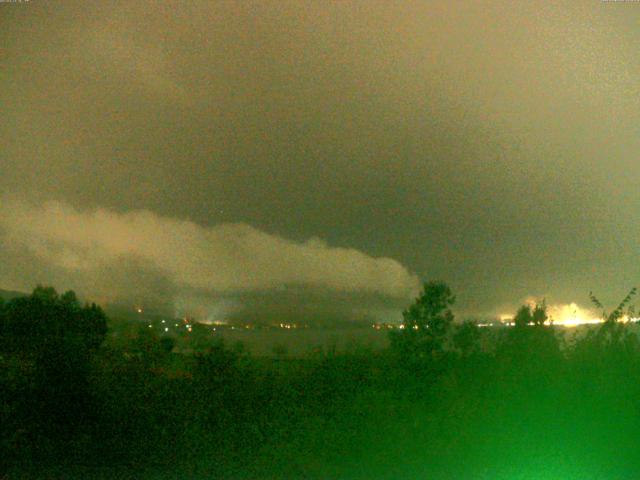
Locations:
0;198;420;308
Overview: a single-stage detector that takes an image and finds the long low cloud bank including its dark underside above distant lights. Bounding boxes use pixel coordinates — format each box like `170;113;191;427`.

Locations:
0;198;419;324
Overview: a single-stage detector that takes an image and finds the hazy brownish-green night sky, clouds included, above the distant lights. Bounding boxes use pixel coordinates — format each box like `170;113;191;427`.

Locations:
0;0;640;320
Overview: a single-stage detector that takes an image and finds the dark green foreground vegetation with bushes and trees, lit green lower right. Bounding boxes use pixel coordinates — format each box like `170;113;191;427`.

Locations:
0;283;640;479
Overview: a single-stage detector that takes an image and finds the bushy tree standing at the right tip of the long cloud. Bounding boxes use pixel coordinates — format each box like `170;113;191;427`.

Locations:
391;281;455;357
